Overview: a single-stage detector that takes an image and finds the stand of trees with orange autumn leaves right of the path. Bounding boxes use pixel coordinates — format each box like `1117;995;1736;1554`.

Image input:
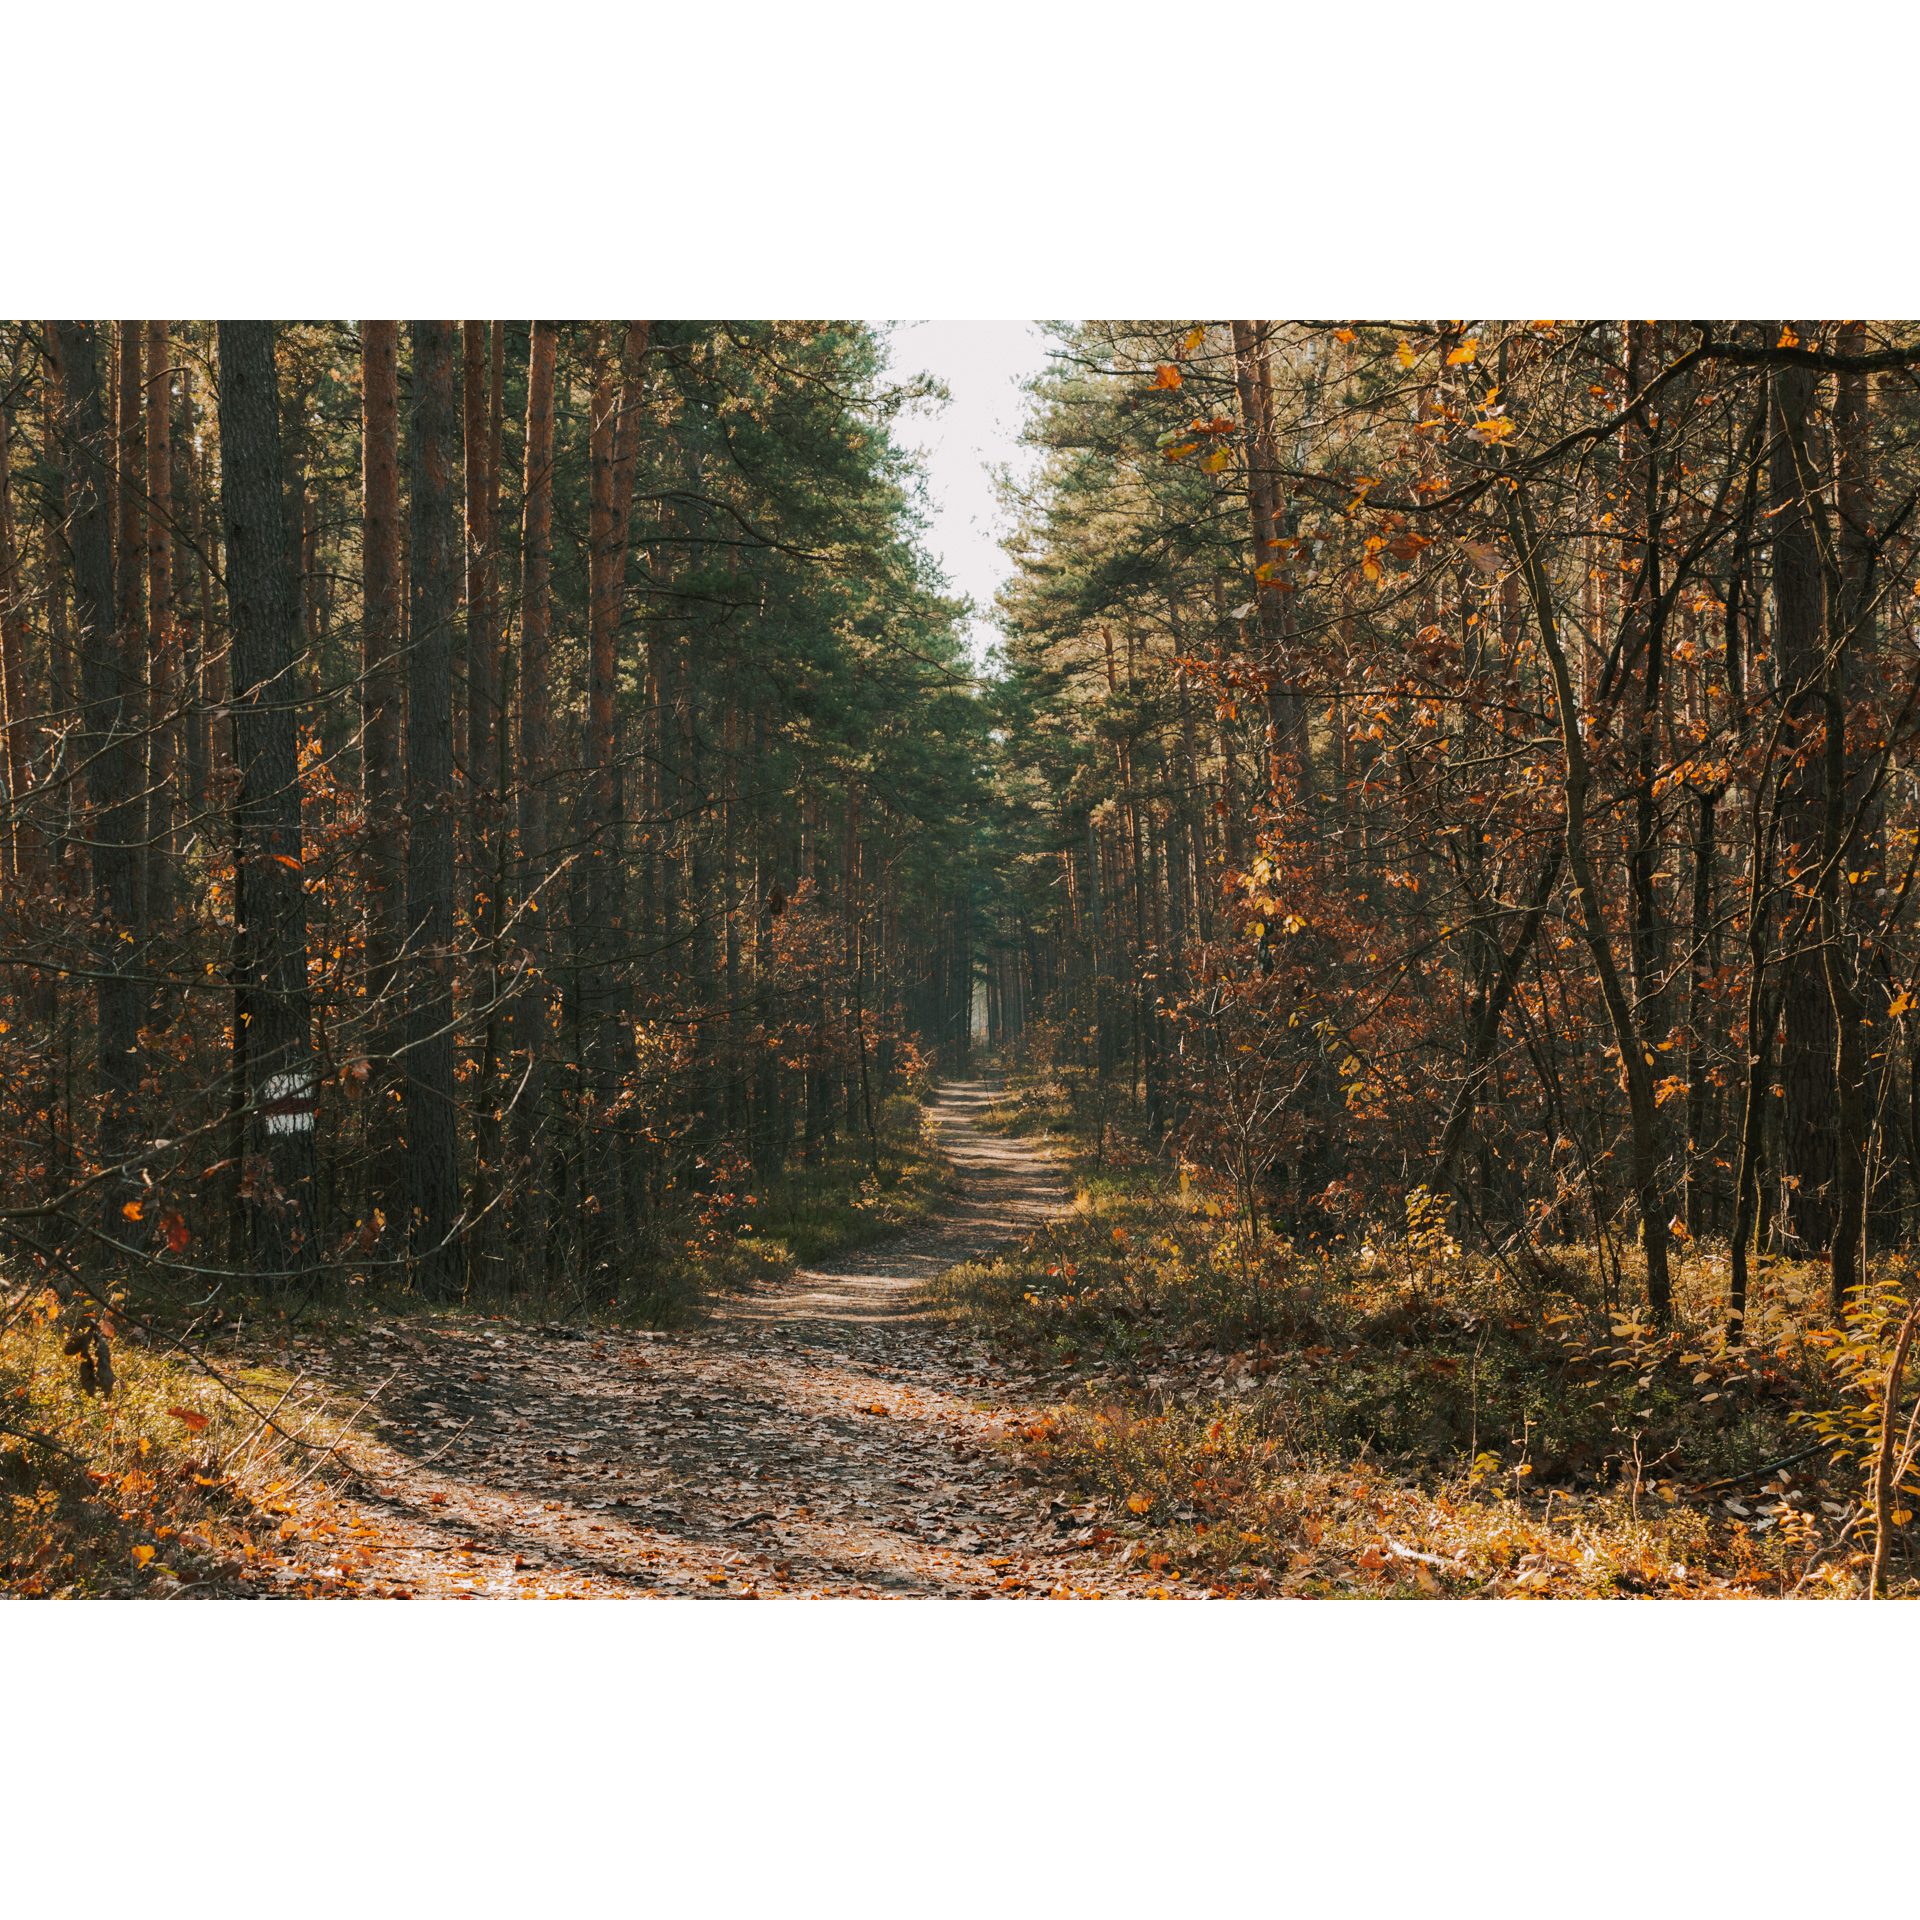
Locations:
983;321;1920;1331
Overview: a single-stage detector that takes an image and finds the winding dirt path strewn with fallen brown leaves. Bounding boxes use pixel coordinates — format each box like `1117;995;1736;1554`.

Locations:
259;1081;1167;1599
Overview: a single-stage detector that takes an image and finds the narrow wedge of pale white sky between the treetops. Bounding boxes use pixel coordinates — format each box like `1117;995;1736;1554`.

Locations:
891;321;1046;660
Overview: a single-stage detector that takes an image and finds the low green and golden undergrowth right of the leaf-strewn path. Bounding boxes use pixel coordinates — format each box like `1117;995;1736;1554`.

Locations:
935;1059;1920;1594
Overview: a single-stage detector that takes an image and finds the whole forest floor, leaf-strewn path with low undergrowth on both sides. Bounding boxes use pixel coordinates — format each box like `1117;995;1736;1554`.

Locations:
18;1075;1916;1599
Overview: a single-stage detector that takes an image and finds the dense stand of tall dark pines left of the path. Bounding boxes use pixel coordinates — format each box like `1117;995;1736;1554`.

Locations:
0;321;987;1300
